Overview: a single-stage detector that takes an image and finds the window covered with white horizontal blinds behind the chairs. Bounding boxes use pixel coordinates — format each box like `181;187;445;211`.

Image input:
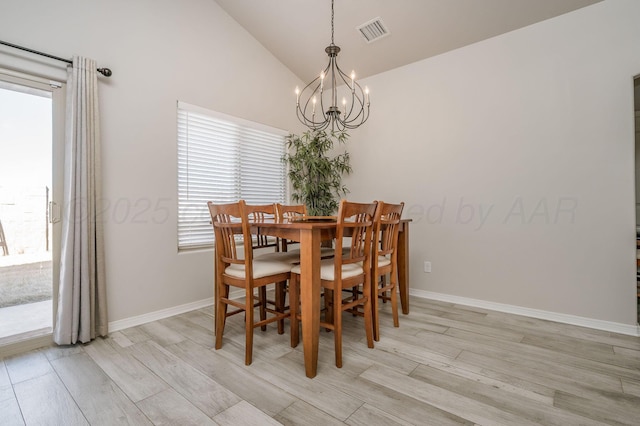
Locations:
178;102;287;250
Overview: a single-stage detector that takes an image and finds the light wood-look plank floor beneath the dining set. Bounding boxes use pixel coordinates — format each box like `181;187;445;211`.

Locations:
0;297;640;426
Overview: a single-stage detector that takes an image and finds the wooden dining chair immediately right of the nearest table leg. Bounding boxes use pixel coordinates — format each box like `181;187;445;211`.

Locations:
289;200;377;368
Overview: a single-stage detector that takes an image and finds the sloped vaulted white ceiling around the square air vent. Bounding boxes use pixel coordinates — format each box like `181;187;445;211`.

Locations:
215;0;602;81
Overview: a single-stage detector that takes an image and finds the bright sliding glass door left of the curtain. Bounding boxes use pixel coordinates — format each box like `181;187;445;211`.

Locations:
0;70;64;349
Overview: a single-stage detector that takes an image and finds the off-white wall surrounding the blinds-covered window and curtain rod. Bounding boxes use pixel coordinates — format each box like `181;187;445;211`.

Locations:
0;0;300;322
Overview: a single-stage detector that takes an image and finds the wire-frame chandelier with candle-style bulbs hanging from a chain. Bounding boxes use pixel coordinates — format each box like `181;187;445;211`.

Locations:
296;0;369;131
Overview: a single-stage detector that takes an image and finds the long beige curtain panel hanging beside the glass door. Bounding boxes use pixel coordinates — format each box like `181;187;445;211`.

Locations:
53;57;108;345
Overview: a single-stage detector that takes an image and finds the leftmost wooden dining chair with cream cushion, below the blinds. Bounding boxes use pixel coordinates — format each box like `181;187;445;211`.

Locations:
208;200;291;365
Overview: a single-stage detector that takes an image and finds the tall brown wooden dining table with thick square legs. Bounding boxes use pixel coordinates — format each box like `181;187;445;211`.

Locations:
252;216;411;378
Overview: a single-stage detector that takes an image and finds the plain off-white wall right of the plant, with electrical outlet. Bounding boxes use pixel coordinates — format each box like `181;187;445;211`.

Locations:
347;0;640;325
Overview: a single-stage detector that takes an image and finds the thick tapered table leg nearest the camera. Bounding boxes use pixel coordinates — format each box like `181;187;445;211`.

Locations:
300;229;321;378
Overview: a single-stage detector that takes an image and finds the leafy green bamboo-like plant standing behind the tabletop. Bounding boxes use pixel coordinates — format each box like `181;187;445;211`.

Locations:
282;130;351;216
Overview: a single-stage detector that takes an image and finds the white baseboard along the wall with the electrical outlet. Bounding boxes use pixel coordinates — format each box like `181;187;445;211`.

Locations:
416;289;640;336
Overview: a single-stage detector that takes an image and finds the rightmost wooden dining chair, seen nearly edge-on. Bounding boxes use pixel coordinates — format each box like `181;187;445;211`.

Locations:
371;201;404;341
